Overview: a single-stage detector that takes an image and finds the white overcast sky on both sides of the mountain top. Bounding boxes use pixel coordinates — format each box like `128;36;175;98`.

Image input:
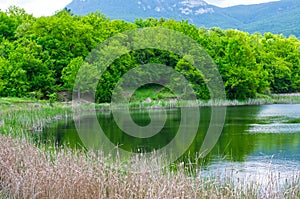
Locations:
0;0;276;17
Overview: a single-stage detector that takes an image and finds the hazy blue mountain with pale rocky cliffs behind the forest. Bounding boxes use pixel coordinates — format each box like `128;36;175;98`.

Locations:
66;0;300;38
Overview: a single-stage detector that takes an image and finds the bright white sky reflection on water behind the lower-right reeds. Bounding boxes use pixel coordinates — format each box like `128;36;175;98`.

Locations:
198;156;300;188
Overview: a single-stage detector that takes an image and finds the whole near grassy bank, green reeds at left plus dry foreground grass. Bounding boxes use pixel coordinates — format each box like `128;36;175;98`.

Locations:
0;99;300;198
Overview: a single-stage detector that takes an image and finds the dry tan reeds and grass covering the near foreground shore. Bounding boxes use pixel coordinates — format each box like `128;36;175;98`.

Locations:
0;135;300;198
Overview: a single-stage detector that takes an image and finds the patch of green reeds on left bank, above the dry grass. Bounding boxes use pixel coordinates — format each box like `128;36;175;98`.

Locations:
0;98;72;137
